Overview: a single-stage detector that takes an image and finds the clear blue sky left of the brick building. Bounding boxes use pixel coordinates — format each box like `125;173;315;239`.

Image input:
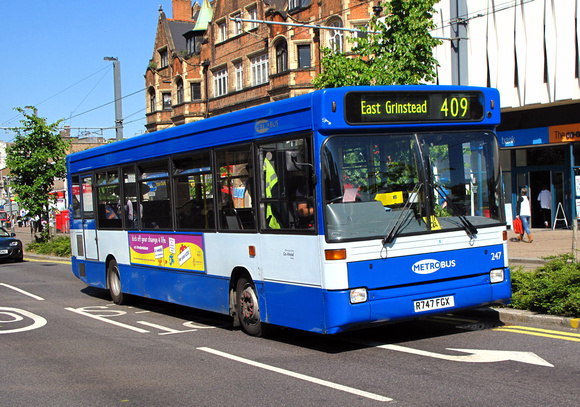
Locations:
0;0;186;142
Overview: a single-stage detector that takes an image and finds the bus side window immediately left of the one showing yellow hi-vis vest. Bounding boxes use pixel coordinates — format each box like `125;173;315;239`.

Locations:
214;145;256;230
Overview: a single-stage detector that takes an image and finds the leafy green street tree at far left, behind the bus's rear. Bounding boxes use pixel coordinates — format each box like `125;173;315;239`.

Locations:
6;106;68;241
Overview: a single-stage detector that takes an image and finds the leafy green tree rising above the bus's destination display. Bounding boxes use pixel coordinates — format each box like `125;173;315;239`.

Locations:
312;0;442;89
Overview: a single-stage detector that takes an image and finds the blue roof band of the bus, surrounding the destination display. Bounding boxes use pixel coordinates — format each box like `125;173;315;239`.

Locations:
67;85;500;172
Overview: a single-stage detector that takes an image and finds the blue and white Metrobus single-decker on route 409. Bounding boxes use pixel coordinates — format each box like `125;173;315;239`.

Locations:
67;85;511;335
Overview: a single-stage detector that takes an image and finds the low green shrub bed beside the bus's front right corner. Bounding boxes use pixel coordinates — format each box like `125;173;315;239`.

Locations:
511;254;580;317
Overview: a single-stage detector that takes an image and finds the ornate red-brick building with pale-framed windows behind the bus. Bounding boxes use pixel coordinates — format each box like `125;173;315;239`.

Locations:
145;0;376;132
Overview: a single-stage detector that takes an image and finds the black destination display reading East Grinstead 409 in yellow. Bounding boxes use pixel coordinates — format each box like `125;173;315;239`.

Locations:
344;92;484;124
